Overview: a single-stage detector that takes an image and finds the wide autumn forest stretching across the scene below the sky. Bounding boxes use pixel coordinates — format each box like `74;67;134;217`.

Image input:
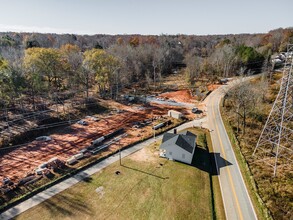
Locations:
0;28;293;107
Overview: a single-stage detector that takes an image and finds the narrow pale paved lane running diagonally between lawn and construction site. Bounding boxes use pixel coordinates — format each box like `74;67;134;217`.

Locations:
0;119;205;220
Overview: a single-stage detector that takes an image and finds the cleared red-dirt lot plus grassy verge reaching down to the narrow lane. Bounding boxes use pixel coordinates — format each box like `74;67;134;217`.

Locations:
0;99;194;208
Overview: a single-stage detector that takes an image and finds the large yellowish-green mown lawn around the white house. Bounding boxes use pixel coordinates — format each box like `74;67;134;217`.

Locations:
16;128;225;219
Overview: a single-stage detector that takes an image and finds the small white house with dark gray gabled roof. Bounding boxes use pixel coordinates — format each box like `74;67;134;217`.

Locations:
160;129;196;164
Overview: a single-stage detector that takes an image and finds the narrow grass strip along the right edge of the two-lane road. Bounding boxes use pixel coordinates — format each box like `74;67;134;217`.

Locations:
220;104;273;219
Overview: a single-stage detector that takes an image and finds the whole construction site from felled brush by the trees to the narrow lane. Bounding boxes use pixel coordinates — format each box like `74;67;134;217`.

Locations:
0;87;203;206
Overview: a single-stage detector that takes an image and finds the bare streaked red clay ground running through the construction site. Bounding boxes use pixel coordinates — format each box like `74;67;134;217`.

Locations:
0;105;188;185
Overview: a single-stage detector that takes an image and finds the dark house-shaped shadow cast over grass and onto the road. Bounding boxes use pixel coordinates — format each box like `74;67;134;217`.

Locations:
191;147;232;176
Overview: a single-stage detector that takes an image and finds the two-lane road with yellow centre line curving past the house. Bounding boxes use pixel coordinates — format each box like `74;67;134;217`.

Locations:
204;80;257;220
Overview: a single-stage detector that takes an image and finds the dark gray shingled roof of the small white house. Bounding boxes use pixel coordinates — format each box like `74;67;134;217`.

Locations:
160;131;196;154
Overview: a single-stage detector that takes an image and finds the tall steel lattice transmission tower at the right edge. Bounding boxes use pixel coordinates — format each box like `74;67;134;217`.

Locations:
253;44;293;176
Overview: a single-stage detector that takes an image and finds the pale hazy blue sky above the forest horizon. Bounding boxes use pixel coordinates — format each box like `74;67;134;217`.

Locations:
0;0;293;35
